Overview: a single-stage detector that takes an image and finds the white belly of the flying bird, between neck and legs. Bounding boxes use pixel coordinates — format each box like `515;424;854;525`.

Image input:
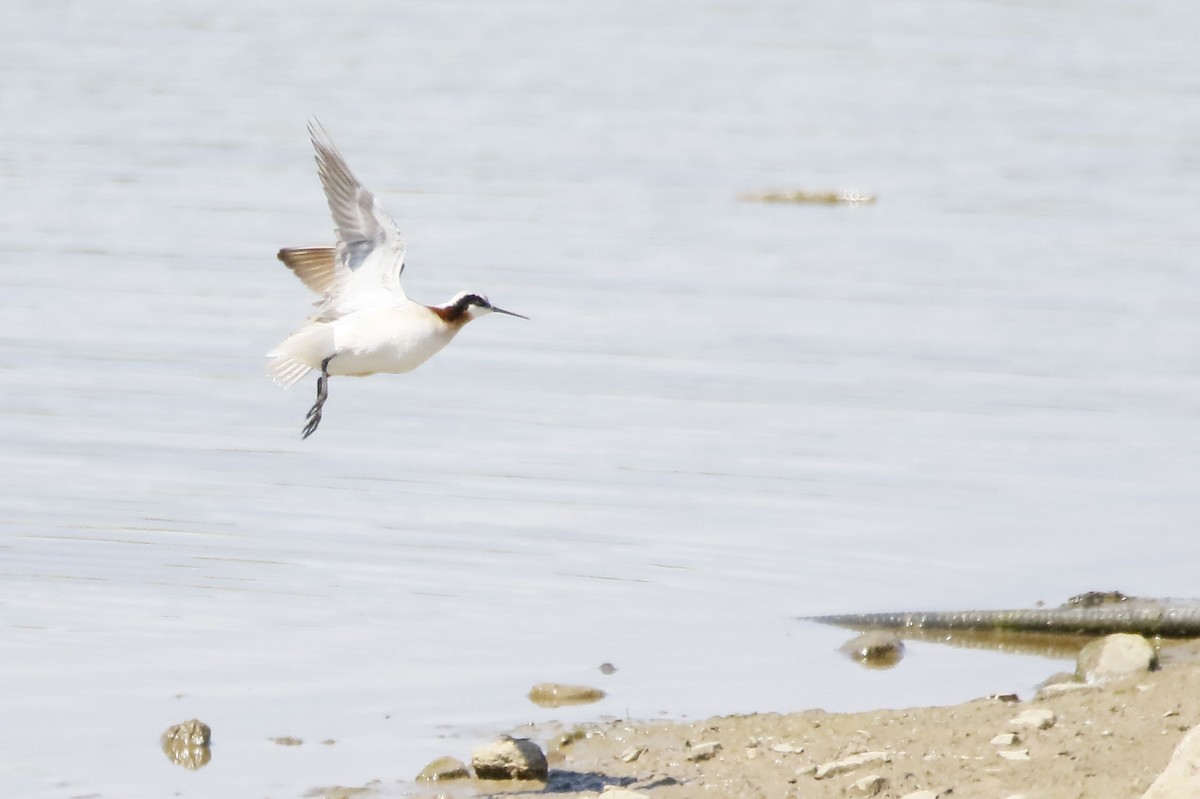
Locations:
329;305;457;376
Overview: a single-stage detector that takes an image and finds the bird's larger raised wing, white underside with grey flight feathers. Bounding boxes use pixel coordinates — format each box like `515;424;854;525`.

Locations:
304;120;407;318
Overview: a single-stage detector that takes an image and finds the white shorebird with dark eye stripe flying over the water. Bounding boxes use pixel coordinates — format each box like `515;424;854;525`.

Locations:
266;121;528;438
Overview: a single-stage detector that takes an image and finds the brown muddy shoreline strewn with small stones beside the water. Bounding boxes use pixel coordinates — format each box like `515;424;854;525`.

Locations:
398;644;1200;799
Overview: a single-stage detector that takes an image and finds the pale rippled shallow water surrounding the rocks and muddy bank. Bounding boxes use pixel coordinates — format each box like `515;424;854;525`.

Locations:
0;0;1200;797
